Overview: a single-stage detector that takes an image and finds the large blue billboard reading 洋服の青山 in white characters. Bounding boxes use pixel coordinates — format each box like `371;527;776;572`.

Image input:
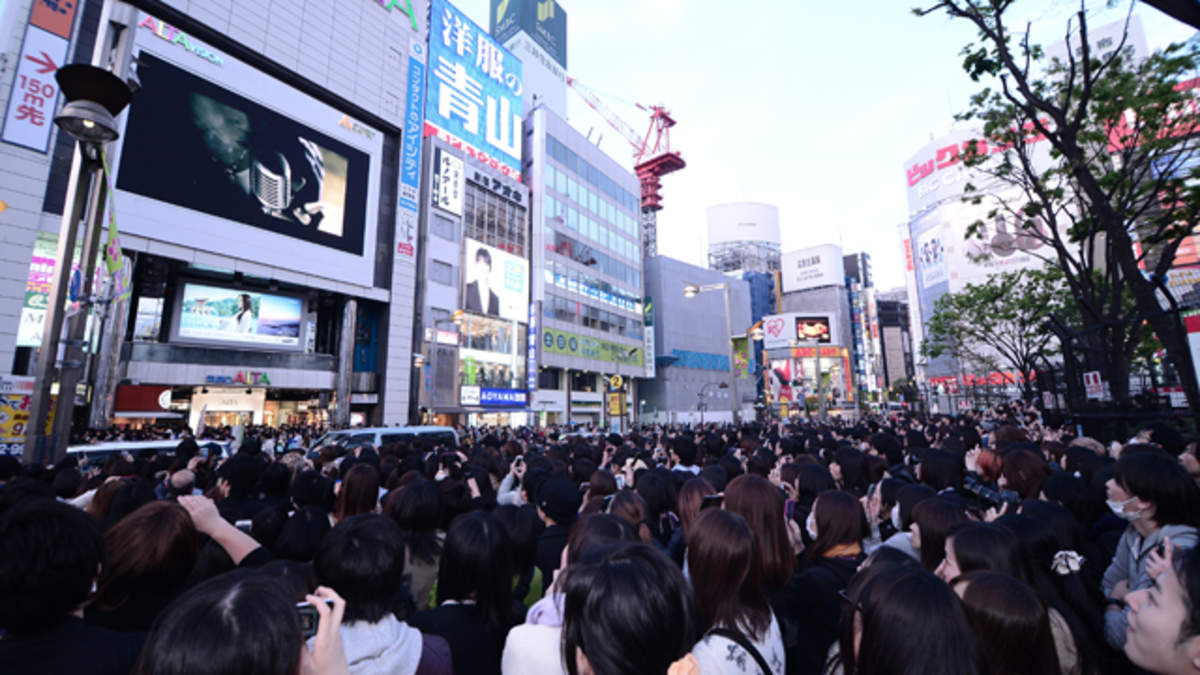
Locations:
425;0;524;180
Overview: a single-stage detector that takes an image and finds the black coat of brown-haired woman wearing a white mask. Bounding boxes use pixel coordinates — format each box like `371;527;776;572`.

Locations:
770;554;865;675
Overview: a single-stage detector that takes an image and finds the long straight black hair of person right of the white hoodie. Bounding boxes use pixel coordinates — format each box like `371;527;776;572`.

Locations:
438;510;512;638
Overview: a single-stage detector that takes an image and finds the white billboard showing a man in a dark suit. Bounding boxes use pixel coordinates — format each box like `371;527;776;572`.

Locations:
462;239;529;323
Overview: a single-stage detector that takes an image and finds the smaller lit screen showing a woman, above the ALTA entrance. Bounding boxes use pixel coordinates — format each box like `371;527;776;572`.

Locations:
175;283;304;348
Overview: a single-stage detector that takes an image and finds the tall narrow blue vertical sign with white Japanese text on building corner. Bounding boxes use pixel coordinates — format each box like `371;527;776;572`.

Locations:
396;42;425;259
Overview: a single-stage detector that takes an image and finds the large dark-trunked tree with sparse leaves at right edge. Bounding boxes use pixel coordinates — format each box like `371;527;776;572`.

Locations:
914;0;1200;410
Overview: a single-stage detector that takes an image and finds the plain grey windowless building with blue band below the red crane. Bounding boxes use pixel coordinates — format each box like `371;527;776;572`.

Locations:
638;256;757;423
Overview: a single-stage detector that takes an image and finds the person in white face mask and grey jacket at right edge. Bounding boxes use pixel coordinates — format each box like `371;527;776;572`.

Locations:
1100;453;1200;650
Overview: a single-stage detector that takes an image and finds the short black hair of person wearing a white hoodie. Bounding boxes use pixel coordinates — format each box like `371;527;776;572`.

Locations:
313;513;404;623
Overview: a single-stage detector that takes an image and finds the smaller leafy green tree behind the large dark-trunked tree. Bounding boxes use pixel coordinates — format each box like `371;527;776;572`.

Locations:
920;268;1063;400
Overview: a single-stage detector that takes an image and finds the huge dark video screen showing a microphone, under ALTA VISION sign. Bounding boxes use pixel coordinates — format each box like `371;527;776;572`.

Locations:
116;52;370;255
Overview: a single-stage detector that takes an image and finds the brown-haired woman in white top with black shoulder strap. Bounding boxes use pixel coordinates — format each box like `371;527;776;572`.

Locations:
688;508;786;675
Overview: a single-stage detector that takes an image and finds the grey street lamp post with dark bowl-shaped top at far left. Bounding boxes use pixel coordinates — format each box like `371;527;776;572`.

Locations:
23;64;133;464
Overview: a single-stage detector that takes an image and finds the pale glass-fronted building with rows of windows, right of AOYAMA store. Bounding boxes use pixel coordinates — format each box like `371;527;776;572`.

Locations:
524;107;654;424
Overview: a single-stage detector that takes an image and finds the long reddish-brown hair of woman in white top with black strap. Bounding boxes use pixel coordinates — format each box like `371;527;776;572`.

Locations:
688;508;770;640
